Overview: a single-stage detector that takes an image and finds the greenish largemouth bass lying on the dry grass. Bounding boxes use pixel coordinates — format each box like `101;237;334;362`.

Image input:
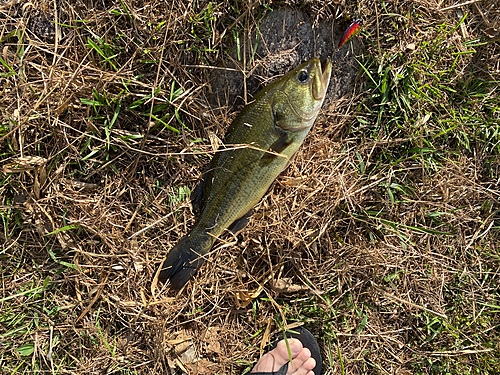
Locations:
155;58;332;290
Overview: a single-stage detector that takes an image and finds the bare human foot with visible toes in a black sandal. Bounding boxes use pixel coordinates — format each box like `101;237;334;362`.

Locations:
251;338;316;375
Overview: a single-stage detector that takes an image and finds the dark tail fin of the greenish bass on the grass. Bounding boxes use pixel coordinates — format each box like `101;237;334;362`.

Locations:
158;236;210;290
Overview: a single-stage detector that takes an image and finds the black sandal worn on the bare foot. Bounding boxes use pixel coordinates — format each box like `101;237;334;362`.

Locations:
249;327;322;375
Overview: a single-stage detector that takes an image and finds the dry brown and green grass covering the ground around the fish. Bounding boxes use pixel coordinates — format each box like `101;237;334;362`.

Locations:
0;0;500;374
